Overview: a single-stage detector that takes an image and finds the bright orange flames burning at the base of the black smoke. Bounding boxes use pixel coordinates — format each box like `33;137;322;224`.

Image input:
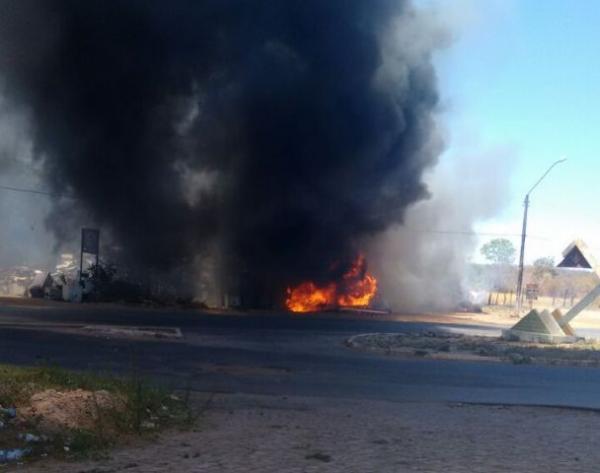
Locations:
285;255;377;312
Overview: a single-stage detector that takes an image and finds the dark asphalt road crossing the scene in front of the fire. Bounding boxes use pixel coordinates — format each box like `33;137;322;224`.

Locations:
0;305;600;409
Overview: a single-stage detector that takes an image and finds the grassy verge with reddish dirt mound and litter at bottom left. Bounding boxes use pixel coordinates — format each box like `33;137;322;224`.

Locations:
0;365;194;464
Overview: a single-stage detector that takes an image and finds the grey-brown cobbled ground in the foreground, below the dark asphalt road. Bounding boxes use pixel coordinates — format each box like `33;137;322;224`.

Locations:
10;395;600;473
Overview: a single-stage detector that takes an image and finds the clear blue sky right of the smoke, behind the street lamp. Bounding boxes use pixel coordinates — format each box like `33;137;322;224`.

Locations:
433;0;600;261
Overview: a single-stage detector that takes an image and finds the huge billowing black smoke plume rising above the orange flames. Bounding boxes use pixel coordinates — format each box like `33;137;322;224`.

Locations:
0;0;438;302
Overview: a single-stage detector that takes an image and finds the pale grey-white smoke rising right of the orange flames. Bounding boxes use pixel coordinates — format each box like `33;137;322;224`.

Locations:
367;145;514;312
